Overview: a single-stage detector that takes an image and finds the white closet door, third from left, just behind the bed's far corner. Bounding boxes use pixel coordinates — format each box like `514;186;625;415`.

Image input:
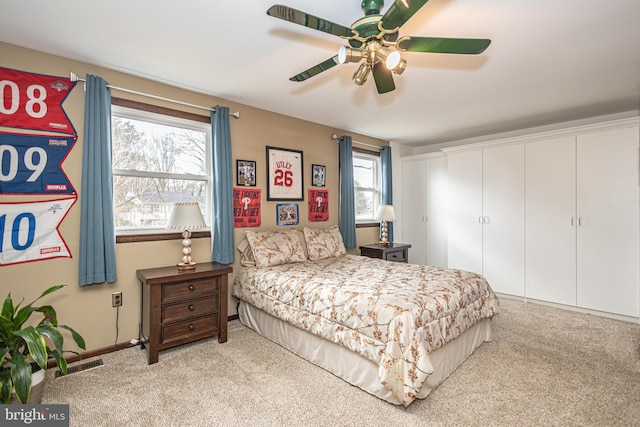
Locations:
447;150;482;273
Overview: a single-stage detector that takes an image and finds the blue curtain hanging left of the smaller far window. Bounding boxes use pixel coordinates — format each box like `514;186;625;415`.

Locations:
338;135;356;248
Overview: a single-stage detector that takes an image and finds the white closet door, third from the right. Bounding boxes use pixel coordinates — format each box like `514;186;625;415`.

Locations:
482;144;524;296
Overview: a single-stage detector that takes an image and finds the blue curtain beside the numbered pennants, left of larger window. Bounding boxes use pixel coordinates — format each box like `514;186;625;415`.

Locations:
78;74;118;286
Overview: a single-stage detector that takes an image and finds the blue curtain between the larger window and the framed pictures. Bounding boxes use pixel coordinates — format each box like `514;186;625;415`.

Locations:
211;105;234;264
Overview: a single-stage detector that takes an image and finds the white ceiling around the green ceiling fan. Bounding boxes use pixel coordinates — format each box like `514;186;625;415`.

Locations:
0;0;640;146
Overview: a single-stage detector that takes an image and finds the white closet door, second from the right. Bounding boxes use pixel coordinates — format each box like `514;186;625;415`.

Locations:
525;136;577;306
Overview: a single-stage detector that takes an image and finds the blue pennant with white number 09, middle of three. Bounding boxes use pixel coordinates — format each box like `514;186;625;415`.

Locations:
0;132;76;194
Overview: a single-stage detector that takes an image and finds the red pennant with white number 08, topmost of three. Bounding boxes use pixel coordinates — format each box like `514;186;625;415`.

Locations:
0;67;77;135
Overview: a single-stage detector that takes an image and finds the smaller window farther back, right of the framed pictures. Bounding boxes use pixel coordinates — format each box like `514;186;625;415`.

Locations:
353;150;380;223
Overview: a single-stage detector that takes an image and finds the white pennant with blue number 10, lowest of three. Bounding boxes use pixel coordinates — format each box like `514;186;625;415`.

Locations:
0;197;76;265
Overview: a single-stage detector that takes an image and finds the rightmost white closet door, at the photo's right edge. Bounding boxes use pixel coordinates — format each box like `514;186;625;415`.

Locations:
577;128;640;317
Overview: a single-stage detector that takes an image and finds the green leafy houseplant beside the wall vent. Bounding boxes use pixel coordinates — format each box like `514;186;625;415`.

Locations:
0;285;85;403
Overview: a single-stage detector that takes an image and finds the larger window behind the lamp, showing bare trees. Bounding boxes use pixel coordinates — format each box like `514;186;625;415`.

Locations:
112;105;211;233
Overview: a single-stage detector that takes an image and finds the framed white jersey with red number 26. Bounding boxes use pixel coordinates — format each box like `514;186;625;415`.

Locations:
267;147;304;201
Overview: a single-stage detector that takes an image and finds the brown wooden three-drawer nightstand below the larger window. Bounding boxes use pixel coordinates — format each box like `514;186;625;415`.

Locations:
136;262;233;365
